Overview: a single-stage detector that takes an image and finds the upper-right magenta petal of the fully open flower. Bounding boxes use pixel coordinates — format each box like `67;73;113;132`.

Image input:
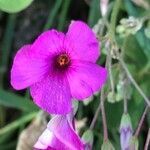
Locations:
65;21;99;62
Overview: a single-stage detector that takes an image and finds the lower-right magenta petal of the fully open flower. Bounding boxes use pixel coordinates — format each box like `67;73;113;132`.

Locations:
68;61;107;100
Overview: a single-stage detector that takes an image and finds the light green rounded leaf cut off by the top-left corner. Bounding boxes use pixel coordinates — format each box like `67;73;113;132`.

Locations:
0;0;33;13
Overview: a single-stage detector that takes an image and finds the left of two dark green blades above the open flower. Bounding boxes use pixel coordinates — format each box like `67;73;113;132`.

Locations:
43;0;63;31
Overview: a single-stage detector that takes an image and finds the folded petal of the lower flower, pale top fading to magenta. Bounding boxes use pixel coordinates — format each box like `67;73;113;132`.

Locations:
48;116;84;150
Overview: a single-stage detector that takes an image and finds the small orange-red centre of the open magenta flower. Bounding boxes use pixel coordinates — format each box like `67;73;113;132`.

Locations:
57;54;70;67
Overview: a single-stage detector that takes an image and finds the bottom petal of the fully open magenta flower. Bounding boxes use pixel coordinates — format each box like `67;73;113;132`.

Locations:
30;76;71;114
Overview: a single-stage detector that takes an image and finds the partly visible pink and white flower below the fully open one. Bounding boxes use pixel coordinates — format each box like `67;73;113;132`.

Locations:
34;114;84;150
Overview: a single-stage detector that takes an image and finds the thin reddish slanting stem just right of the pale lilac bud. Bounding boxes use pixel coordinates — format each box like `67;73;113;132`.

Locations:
134;106;149;137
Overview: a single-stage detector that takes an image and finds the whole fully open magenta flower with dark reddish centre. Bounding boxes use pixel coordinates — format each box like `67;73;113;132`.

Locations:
11;21;107;114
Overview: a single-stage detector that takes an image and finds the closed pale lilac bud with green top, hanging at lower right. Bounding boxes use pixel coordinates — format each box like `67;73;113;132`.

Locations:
120;113;133;150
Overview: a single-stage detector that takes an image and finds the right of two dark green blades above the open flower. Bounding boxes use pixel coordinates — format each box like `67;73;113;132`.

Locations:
58;0;71;30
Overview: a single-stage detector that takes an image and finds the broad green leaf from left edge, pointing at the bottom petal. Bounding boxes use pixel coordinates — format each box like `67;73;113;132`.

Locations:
0;89;38;111
